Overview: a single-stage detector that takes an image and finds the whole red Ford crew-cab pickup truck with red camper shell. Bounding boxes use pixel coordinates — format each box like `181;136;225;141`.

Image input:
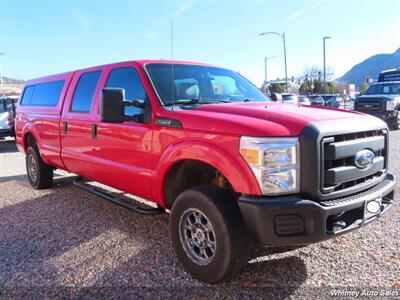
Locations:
16;60;395;282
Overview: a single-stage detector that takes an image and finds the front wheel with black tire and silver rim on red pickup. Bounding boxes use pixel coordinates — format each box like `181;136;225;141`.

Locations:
170;186;248;283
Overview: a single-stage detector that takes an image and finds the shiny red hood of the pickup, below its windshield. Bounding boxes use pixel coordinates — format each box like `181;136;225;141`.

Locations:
169;102;373;136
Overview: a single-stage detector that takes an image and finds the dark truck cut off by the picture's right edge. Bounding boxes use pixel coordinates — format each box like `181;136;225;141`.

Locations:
354;68;400;129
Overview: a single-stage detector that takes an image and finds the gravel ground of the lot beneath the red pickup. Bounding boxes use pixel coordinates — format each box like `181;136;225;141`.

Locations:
0;131;400;299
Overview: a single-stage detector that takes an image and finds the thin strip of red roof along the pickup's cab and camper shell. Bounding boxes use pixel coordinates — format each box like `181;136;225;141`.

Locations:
25;59;217;85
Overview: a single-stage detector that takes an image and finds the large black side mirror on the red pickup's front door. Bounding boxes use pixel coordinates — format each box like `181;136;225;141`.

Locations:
100;88;145;123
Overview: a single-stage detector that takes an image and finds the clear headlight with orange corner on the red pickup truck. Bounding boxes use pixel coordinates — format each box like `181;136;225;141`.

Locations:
240;136;300;195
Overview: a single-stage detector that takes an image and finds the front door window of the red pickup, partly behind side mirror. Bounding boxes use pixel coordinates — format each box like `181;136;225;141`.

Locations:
106;67;148;122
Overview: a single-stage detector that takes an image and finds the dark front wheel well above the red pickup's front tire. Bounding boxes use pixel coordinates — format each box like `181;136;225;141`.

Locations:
163;160;234;208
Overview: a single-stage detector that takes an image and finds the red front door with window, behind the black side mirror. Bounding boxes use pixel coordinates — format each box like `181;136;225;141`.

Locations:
91;63;153;200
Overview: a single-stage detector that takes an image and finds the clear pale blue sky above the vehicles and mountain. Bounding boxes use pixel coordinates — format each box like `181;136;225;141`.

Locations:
0;0;400;85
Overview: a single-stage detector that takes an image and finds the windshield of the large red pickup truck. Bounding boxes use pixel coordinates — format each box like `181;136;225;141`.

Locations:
145;63;268;105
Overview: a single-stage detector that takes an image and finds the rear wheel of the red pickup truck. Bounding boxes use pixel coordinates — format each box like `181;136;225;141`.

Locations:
25;147;53;190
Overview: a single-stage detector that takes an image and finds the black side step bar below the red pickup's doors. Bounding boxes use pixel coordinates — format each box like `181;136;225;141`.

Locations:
72;177;165;215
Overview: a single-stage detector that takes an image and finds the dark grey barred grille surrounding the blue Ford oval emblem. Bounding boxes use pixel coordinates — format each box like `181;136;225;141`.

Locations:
320;130;387;194
